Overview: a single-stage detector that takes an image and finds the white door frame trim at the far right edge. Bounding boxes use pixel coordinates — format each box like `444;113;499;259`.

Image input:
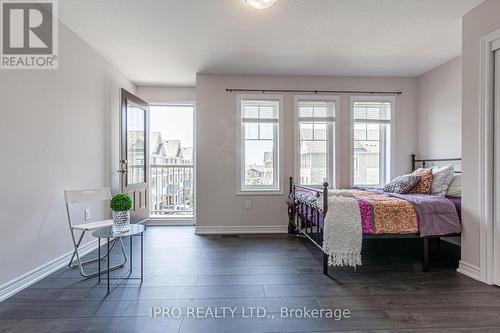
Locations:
476;29;500;284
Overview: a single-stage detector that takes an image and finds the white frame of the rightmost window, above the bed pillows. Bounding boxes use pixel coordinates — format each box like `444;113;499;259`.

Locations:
349;95;397;187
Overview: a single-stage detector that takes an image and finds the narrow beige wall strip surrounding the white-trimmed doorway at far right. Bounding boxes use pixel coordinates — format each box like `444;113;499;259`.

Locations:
462;0;500;267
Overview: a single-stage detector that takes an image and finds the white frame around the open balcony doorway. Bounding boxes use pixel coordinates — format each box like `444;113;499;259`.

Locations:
147;100;198;226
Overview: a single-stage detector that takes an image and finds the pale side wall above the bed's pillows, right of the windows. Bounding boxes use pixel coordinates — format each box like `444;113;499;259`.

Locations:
417;57;462;158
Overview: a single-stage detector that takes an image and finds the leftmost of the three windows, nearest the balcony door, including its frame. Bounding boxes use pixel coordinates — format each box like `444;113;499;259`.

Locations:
238;95;282;192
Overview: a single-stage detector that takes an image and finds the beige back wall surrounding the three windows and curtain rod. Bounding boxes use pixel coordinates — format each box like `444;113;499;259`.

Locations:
196;74;418;227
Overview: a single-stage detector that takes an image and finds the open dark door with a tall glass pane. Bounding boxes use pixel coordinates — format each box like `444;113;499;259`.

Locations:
118;89;150;223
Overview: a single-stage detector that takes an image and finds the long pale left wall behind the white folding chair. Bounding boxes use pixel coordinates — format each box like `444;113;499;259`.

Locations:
0;25;135;286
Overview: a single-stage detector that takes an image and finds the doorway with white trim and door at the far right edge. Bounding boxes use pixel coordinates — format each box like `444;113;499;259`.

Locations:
476;29;500;285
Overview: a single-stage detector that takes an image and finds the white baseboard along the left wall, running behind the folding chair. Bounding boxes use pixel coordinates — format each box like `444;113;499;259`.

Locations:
0;240;97;302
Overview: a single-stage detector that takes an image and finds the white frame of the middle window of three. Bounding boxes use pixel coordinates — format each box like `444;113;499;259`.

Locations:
293;95;341;188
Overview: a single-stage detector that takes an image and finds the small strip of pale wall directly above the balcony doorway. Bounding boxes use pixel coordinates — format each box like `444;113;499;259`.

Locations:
137;86;196;103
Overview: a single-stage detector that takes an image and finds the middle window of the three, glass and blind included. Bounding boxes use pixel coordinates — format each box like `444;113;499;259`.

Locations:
295;96;337;186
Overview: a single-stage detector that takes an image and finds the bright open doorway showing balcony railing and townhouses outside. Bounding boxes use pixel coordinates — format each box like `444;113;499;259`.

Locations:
149;104;196;225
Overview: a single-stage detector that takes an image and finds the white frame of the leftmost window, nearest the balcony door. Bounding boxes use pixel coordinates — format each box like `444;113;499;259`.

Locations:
236;94;284;195
